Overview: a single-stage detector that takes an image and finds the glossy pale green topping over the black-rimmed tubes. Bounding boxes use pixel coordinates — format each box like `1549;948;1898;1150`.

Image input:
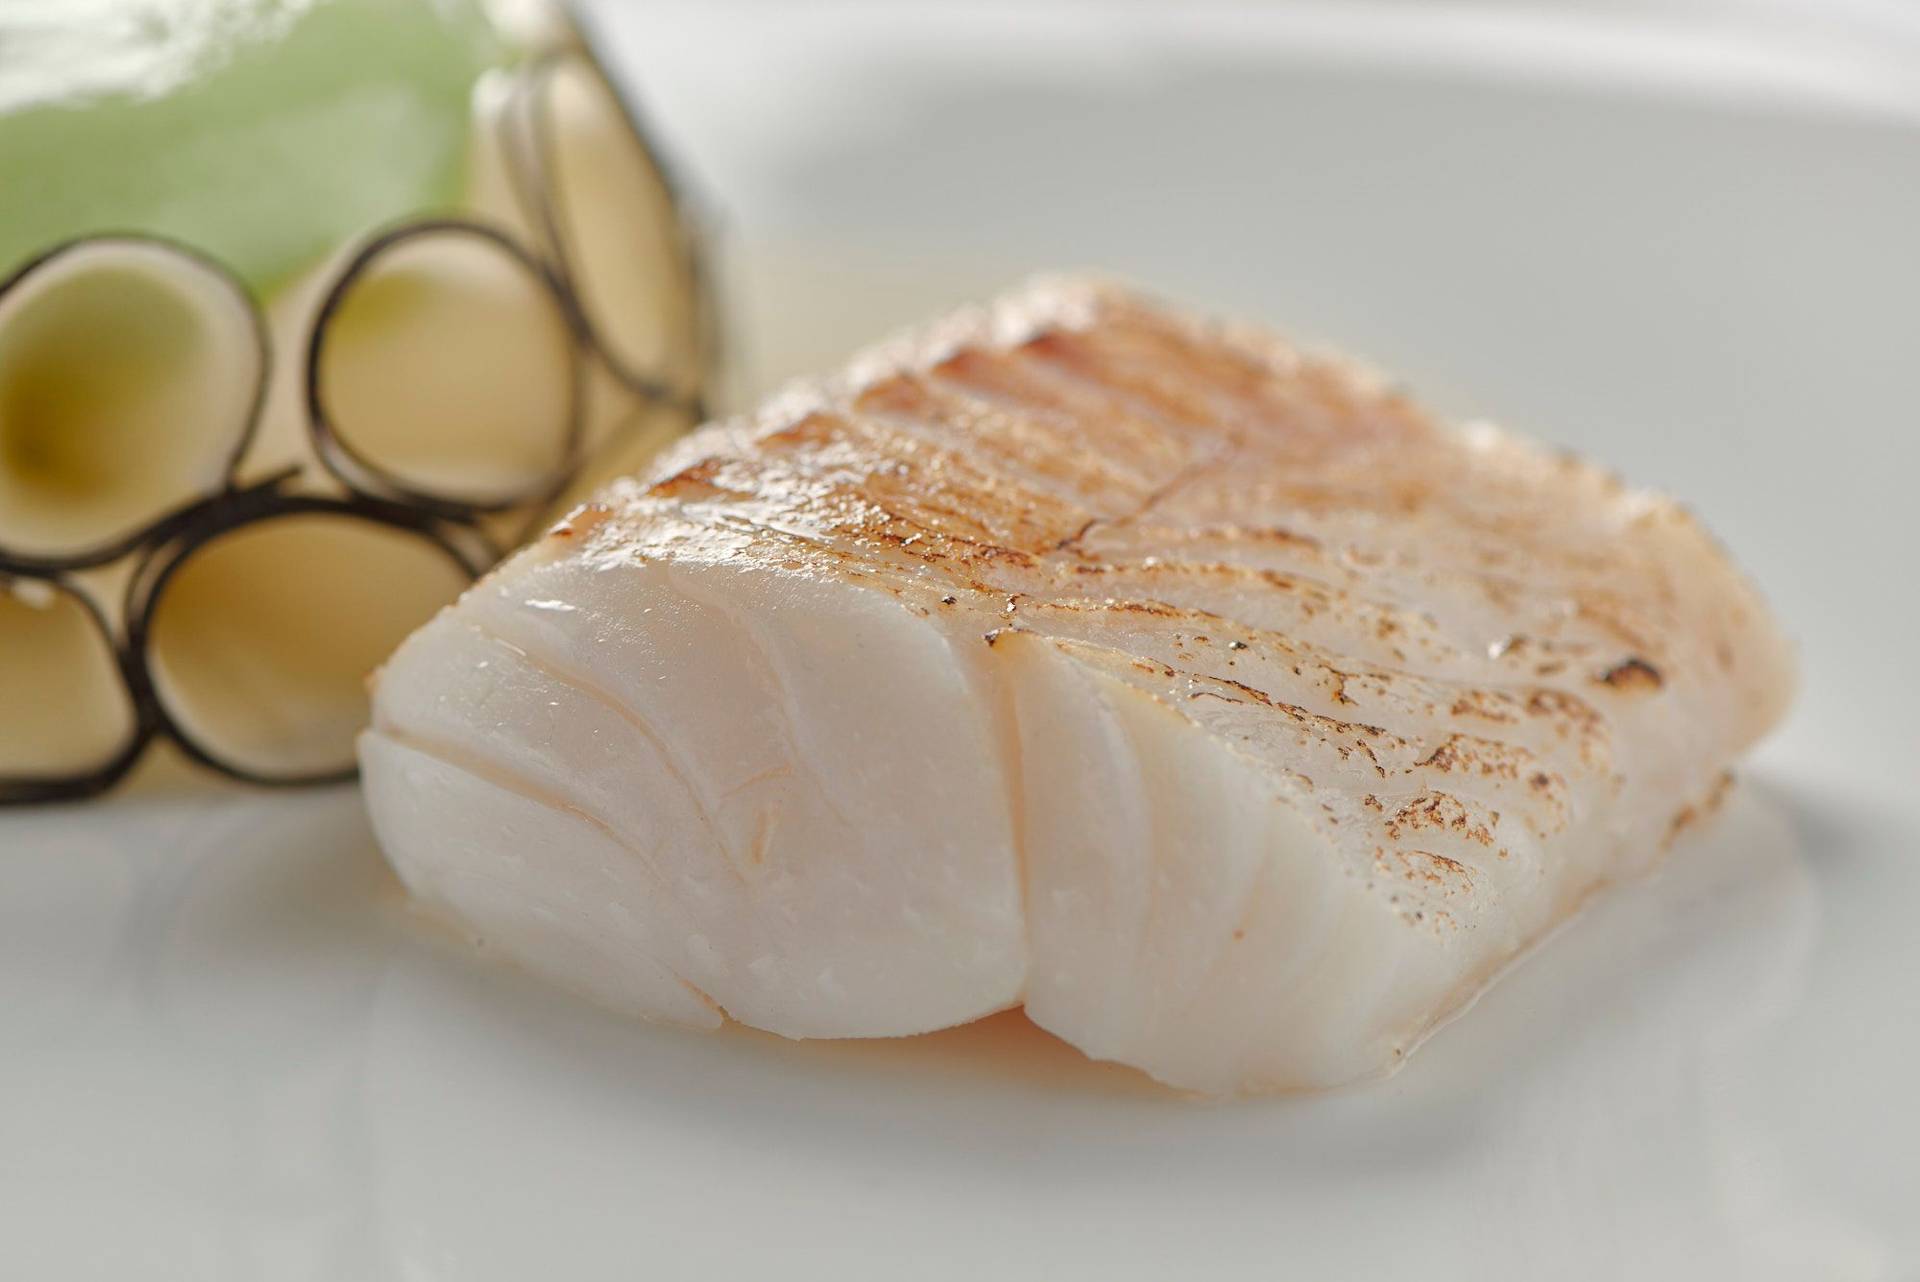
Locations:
0;0;511;294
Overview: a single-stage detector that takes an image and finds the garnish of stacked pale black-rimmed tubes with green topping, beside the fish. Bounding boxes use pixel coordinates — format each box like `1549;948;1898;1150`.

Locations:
0;0;714;802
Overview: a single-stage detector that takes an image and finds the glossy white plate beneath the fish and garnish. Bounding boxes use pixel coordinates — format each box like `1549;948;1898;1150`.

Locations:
0;2;1920;1282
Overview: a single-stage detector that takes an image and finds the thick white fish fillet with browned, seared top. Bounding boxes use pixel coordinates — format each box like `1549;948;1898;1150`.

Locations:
361;282;1791;1094
